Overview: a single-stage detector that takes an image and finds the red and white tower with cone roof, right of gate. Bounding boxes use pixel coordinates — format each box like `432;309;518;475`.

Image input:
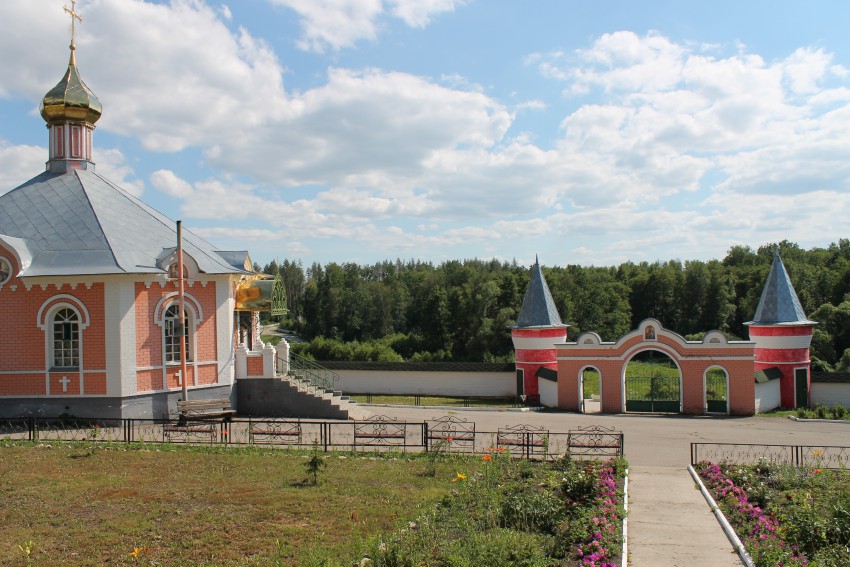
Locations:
745;252;817;408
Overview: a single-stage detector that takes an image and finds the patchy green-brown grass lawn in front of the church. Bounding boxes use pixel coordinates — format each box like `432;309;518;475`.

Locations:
0;442;479;566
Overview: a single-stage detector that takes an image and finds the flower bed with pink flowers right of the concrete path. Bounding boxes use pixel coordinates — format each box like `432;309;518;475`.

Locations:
697;462;850;567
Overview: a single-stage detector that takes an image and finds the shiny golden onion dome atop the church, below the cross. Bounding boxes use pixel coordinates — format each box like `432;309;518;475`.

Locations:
39;48;103;124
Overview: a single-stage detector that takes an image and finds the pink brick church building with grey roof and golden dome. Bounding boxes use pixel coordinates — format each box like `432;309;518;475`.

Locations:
0;8;280;418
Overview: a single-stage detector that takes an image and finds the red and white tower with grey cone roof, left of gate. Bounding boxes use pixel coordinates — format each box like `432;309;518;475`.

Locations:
511;258;568;396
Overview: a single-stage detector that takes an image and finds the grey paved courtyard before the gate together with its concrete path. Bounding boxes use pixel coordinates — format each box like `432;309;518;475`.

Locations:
364;406;850;567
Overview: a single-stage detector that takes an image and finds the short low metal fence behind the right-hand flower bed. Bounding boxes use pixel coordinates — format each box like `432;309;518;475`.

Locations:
691;443;850;469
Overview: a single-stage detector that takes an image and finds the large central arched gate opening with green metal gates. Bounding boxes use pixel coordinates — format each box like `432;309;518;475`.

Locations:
623;349;682;413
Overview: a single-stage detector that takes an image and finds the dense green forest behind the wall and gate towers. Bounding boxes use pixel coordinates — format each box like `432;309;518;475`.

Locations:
258;239;850;371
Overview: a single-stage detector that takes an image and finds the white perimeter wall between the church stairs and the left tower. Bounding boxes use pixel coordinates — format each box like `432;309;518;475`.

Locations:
334;370;516;396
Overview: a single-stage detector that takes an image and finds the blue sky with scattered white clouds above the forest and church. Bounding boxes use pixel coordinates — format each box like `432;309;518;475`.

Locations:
0;0;850;265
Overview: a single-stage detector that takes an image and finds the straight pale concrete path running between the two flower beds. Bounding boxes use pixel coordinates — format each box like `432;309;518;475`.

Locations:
629;466;742;567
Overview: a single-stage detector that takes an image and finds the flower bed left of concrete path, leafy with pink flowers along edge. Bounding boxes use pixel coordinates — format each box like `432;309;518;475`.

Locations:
365;450;625;567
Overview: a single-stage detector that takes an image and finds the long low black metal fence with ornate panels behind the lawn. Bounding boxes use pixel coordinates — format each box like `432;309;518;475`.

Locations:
0;416;623;459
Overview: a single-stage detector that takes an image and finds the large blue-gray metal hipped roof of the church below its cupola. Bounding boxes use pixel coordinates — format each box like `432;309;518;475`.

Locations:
0;170;243;277
